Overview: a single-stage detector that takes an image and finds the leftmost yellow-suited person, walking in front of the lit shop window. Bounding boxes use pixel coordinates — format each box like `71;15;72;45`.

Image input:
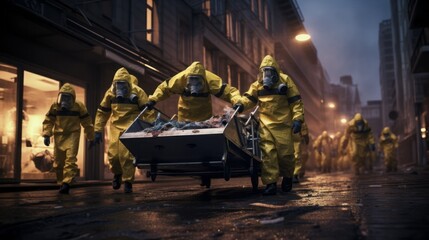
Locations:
42;83;94;194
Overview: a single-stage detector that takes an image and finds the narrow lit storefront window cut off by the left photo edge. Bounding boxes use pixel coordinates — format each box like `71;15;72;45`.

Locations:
0;63;17;178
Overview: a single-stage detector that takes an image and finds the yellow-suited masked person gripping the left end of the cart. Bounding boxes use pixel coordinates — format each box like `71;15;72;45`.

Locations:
94;67;155;193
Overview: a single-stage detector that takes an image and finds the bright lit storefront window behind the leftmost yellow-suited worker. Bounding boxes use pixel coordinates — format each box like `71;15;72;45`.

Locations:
21;71;85;179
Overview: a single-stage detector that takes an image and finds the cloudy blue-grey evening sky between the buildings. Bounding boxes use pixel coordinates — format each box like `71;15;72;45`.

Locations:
297;0;390;105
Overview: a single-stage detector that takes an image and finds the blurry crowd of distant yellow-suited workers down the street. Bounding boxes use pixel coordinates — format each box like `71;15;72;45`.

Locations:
313;113;398;175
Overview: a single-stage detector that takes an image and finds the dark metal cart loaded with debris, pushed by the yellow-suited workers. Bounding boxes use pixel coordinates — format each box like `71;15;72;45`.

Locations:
120;108;261;190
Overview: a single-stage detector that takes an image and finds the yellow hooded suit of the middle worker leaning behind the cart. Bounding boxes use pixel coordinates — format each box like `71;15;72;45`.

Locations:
149;62;240;122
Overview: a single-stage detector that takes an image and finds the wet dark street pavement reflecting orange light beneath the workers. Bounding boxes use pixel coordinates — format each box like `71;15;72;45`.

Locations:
0;170;429;239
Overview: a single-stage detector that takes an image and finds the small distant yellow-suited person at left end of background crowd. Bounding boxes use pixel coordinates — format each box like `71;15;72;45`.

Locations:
314;131;332;172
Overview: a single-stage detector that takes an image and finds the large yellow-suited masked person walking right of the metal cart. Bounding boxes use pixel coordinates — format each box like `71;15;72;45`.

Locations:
235;55;304;196
